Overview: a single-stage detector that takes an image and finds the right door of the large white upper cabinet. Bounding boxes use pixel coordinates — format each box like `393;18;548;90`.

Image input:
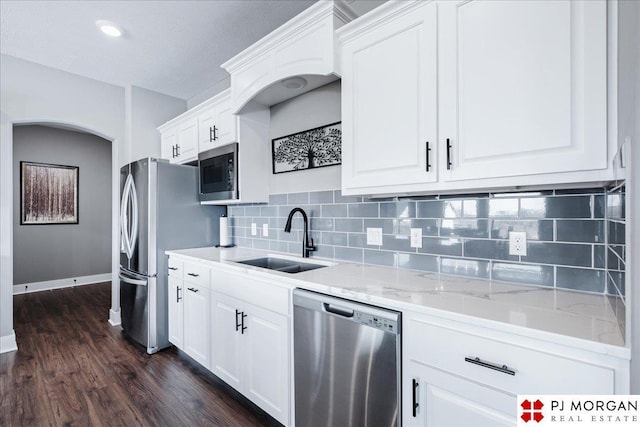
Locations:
438;0;607;184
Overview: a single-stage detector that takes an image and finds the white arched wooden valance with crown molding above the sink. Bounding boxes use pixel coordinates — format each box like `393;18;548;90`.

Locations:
222;1;356;113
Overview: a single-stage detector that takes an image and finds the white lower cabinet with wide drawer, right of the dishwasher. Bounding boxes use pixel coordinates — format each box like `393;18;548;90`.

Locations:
403;312;629;427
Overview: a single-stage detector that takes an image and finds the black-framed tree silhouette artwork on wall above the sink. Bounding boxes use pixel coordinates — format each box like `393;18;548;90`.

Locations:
271;122;342;174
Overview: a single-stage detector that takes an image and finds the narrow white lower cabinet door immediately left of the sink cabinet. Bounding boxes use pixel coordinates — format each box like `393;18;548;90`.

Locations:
183;282;211;368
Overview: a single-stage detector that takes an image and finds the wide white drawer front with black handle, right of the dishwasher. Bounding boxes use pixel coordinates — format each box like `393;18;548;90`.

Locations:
405;318;615;394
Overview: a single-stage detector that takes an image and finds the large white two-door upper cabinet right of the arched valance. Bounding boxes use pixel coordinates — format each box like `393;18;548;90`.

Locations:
337;0;616;194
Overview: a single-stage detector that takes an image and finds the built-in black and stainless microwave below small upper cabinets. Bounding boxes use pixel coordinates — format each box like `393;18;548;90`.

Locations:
198;143;239;202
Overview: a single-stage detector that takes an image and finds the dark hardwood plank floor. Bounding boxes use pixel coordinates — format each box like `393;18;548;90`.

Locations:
0;283;279;426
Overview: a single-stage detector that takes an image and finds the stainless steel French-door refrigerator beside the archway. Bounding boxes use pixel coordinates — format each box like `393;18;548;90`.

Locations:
119;158;226;354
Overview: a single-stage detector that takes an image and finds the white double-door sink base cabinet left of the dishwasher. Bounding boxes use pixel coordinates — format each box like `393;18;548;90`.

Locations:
211;270;291;425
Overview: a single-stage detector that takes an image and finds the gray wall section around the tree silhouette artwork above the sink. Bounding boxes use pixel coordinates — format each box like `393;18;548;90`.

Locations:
266;81;342;194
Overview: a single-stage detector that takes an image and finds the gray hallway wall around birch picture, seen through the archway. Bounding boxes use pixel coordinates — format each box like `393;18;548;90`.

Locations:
13;126;111;285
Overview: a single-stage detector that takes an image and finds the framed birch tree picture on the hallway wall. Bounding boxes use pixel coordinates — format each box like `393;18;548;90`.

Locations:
20;162;79;225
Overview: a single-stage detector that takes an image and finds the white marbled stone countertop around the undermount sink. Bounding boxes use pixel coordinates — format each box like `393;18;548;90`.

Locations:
166;247;630;358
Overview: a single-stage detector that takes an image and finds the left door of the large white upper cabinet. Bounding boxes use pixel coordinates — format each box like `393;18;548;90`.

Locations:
341;3;438;194
